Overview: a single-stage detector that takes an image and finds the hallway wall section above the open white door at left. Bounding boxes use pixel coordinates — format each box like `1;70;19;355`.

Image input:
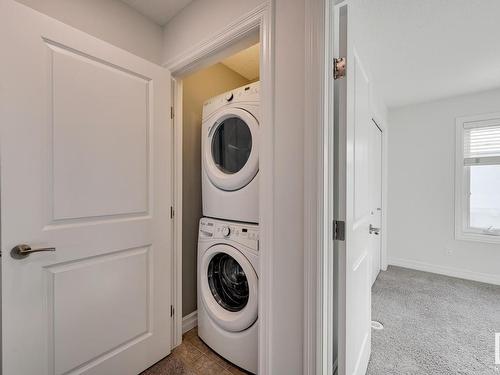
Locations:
17;0;163;64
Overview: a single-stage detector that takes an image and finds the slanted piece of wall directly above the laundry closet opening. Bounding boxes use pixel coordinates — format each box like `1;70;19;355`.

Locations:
163;0;265;64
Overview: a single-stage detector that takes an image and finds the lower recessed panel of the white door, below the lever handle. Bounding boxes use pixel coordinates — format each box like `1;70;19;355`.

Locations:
44;245;153;374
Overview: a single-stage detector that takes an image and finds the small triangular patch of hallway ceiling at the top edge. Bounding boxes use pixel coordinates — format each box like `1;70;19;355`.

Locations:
121;0;193;26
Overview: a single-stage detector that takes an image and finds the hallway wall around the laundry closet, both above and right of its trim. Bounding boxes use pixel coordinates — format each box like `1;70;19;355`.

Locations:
164;0;306;375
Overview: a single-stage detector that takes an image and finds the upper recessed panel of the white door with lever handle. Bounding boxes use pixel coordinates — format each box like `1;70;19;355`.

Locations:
45;40;153;223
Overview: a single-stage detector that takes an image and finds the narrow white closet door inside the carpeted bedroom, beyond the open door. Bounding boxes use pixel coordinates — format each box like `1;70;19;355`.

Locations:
370;120;382;284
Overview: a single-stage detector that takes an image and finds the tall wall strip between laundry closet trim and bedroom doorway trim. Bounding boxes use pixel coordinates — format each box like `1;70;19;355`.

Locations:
270;0;307;375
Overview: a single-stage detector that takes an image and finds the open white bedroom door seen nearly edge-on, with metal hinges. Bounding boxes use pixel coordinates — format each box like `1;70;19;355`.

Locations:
333;5;372;375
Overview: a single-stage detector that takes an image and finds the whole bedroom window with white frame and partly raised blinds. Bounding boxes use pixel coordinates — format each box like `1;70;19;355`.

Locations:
455;113;500;242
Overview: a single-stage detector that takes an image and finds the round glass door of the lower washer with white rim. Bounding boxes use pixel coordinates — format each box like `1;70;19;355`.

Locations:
200;244;258;332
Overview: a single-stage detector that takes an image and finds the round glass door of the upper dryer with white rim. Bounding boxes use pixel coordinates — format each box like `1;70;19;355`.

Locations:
203;108;259;191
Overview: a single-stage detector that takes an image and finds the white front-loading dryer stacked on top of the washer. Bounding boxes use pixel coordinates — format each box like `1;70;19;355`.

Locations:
201;82;260;223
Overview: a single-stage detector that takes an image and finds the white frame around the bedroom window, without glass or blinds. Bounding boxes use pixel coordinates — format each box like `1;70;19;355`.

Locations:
455;112;500;244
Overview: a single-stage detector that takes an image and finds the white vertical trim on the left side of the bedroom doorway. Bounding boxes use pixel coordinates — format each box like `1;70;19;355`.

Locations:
303;0;333;375
